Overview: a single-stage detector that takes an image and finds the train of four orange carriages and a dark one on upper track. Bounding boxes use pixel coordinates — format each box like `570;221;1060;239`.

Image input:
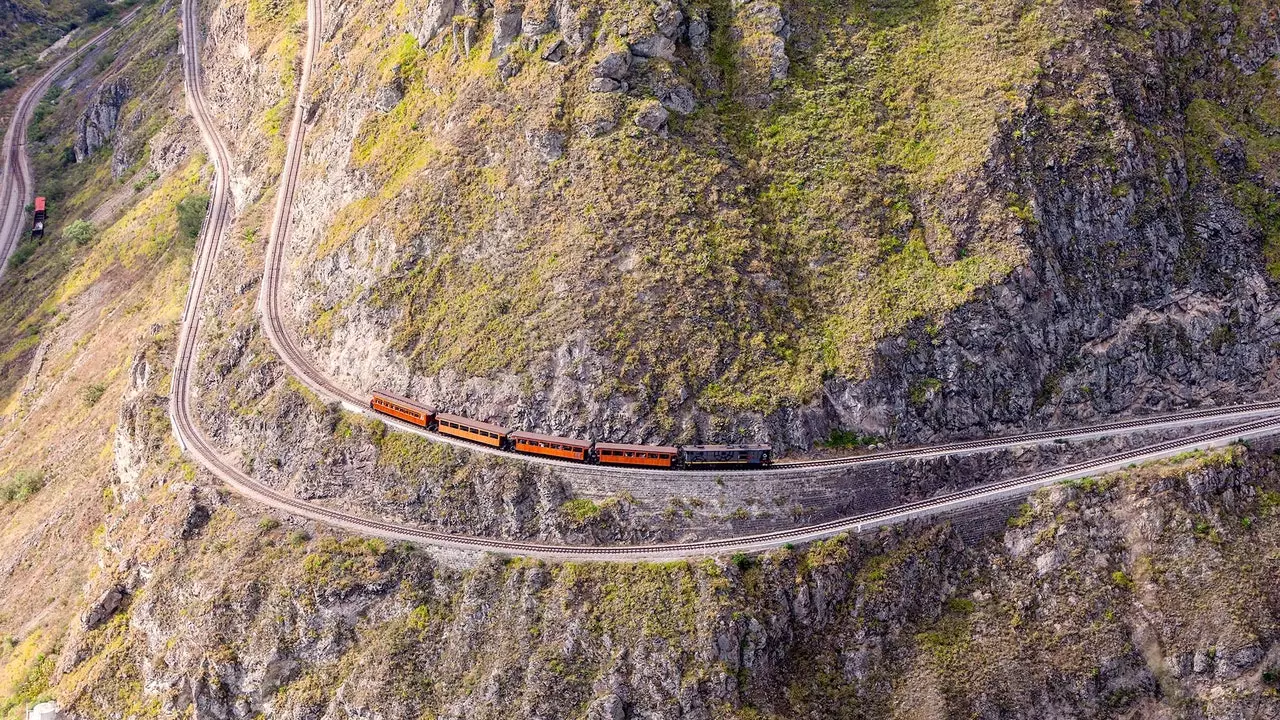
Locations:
369;391;773;470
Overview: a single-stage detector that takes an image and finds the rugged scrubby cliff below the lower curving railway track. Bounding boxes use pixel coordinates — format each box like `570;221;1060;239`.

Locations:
45;435;1280;720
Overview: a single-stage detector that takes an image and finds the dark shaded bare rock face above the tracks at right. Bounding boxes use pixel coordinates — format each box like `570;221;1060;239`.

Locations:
798;4;1280;443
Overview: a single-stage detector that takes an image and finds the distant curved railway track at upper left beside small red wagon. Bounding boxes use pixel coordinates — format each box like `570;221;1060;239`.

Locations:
0;8;141;278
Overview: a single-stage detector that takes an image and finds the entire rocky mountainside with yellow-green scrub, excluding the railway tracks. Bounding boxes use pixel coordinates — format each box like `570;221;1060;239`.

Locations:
0;0;1280;720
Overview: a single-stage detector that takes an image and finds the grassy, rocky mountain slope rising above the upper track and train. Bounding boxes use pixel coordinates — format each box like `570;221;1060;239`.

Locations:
252;1;1280;447
